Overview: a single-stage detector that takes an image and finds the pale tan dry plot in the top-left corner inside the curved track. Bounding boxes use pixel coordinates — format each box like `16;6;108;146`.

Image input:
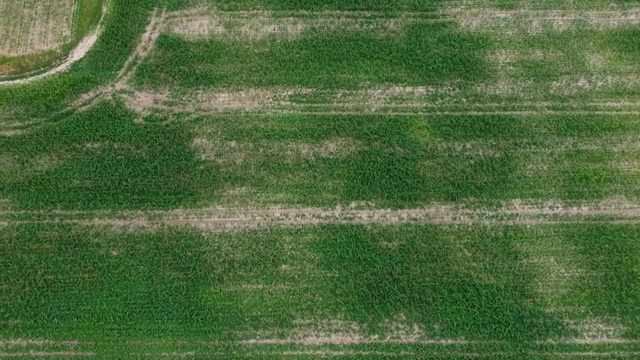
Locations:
0;0;75;56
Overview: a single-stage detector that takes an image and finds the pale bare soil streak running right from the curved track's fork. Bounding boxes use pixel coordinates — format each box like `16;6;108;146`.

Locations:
121;85;640;116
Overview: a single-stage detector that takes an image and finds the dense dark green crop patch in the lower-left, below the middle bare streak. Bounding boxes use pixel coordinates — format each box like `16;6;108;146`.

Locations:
1;226;230;341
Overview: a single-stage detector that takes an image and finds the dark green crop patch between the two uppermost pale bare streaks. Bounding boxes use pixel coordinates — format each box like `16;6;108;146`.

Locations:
136;23;489;88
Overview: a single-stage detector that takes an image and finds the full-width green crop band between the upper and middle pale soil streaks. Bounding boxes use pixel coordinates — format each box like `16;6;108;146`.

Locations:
0;111;640;209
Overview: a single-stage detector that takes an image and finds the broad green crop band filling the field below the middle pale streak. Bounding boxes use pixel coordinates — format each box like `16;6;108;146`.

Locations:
0;224;640;354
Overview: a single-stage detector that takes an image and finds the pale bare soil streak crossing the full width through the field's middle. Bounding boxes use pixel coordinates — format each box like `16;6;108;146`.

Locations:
0;199;640;230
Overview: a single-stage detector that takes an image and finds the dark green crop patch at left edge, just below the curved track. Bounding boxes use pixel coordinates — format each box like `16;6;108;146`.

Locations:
0;103;218;209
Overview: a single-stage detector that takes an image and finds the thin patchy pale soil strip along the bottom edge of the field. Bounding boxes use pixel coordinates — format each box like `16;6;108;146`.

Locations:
0;338;640;359
